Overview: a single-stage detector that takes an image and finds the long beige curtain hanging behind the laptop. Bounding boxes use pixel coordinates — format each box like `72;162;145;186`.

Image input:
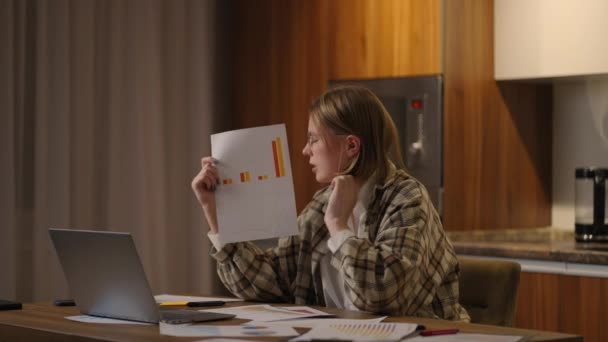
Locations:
0;0;229;301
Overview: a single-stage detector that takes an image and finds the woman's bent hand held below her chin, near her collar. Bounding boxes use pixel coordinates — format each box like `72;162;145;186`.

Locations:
324;175;359;236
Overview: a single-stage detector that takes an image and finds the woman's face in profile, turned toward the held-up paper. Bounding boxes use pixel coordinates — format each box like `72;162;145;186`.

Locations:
302;119;348;183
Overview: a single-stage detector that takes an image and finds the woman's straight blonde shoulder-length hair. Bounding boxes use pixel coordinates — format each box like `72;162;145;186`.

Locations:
308;85;405;182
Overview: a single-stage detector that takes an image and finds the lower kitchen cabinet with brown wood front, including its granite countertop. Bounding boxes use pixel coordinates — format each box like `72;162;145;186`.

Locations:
448;227;608;342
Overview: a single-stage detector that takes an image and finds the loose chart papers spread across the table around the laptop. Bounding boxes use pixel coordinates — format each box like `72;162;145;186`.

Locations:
66;302;522;342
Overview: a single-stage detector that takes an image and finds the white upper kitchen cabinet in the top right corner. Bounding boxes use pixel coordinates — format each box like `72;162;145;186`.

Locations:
494;0;608;80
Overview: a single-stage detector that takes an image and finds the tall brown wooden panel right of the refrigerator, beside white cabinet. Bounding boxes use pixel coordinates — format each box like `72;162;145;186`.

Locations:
444;0;552;230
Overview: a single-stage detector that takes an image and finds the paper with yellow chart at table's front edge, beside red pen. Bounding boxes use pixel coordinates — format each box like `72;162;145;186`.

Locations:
289;323;418;342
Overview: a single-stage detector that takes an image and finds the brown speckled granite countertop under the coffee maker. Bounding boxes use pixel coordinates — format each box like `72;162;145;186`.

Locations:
447;227;608;265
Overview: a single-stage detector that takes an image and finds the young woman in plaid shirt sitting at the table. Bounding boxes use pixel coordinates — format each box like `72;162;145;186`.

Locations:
192;86;469;321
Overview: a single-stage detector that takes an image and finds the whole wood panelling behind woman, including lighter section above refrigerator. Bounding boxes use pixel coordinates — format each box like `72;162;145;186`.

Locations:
233;0;440;212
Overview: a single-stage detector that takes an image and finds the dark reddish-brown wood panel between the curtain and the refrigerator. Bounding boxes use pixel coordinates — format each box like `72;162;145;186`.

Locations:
233;0;328;212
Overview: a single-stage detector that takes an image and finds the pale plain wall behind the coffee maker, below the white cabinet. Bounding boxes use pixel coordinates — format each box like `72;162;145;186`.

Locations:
552;76;608;230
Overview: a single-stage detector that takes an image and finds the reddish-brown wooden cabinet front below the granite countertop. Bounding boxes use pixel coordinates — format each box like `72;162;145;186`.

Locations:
513;272;608;342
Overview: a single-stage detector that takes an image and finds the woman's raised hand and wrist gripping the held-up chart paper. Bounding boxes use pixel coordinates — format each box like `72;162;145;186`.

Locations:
192;157;218;234
